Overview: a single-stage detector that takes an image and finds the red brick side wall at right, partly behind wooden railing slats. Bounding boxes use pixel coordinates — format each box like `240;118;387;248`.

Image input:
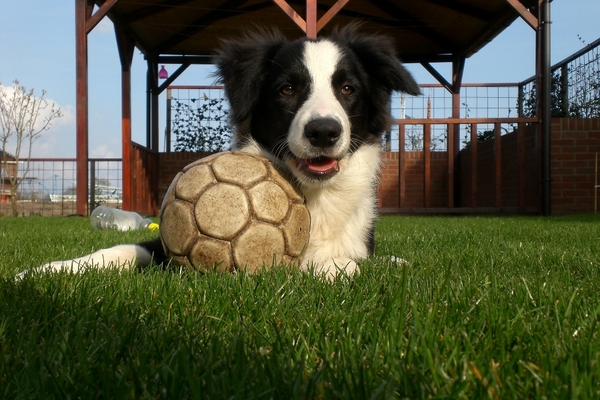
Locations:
460;118;600;215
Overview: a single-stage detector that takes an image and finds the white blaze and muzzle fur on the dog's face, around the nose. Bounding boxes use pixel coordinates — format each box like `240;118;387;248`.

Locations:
288;41;350;158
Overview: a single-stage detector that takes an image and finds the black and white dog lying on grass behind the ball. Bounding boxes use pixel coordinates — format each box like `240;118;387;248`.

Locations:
23;25;420;278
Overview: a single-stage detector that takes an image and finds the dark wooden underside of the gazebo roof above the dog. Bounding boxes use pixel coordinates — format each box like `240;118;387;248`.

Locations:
102;0;538;62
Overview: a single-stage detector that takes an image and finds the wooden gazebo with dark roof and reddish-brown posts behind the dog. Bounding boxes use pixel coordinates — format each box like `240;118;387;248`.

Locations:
75;0;550;215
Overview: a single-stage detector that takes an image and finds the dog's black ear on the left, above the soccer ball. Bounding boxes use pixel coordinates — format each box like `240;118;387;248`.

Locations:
214;29;288;129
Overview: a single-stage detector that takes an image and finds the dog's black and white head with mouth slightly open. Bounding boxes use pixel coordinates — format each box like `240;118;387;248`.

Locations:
216;25;420;185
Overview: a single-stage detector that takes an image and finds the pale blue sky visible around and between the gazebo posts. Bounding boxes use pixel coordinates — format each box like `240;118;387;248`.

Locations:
0;0;600;158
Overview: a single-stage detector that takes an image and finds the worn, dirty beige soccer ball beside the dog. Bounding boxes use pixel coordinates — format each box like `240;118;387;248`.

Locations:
160;152;310;272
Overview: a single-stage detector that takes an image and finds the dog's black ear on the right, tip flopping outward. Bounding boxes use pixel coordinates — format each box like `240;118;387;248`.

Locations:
332;24;421;134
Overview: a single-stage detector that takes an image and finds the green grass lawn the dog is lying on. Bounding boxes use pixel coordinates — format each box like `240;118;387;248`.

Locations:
0;215;600;399
